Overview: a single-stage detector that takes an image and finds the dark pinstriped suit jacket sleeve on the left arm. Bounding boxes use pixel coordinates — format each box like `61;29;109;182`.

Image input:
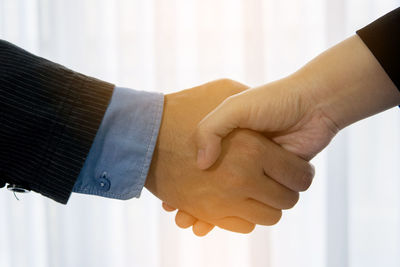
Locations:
0;40;114;204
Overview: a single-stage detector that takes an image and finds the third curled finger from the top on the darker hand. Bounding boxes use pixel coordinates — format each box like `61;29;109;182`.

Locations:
235;199;282;225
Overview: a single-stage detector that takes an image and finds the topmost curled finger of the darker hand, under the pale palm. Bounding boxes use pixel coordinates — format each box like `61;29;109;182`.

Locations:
263;139;315;192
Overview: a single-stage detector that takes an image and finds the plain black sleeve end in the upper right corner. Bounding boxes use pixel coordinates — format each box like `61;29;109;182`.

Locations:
357;8;400;90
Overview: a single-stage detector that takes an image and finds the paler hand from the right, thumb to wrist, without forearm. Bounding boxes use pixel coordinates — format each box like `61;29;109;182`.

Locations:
196;75;339;169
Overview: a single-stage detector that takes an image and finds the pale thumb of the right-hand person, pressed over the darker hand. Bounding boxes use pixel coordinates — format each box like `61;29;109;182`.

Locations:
195;97;245;170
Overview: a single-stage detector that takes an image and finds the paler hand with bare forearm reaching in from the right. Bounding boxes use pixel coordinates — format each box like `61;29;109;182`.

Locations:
169;35;400;237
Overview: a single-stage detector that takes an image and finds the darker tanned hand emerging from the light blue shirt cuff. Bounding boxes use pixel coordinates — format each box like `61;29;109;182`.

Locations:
145;80;314;235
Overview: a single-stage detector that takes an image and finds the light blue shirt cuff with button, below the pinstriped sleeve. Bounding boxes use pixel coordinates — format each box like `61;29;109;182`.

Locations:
73;87;164;199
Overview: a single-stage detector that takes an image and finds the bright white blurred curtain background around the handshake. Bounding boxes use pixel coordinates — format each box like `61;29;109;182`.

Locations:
0;0;400;267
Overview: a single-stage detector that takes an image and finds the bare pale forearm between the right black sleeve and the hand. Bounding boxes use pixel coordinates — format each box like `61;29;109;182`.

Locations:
293;35;400;129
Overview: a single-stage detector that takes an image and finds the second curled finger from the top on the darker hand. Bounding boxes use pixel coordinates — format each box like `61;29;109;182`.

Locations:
249;175;299;210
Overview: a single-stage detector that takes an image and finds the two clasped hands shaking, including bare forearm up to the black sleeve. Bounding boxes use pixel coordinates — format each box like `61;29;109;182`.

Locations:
145;35;400;236
